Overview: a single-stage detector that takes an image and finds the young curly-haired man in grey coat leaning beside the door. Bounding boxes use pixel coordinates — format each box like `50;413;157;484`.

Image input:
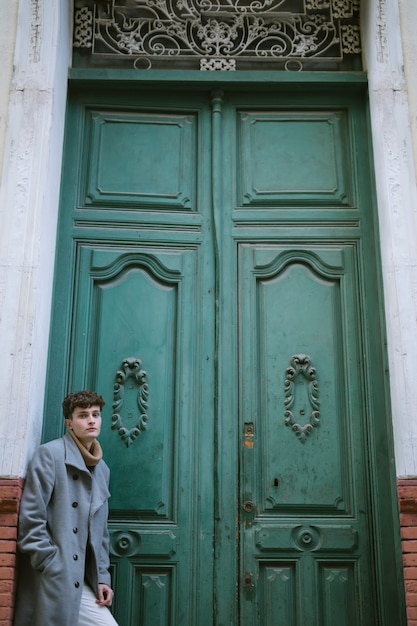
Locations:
14;391;117;626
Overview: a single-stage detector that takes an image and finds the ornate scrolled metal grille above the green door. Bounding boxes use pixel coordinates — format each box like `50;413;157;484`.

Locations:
73;0;361;71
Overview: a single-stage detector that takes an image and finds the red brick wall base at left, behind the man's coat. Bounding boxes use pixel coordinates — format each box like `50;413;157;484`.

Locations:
0;478;23;626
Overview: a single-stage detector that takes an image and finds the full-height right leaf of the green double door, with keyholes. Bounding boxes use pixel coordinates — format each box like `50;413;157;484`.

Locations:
224;94;404;626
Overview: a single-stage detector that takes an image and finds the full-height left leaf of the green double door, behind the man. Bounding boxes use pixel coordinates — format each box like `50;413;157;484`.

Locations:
46;93;214;626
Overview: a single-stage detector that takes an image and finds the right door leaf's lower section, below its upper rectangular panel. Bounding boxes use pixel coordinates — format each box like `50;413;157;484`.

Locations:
239;242;375;626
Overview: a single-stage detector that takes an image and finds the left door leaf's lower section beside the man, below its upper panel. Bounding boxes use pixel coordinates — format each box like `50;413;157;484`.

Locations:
73;244;210;626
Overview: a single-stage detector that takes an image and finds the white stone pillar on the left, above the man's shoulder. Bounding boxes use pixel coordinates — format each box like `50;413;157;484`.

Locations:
0;0;71;476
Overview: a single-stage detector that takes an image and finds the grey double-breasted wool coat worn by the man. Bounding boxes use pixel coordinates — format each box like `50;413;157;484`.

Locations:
14;433;110;626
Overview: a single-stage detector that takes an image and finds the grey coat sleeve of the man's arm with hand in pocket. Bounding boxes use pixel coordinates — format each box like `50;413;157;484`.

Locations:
18;446;57;571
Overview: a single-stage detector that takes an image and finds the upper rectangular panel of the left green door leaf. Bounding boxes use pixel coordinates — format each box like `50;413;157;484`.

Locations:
85;109;197;210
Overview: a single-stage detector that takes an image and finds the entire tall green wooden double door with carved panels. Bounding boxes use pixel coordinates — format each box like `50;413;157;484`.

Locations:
45;79;404;626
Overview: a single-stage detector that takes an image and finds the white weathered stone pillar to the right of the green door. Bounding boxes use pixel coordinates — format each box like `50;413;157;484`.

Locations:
361;0;417;476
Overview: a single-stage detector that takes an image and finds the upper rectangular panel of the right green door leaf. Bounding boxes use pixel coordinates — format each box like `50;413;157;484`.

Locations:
237;108;352;207
